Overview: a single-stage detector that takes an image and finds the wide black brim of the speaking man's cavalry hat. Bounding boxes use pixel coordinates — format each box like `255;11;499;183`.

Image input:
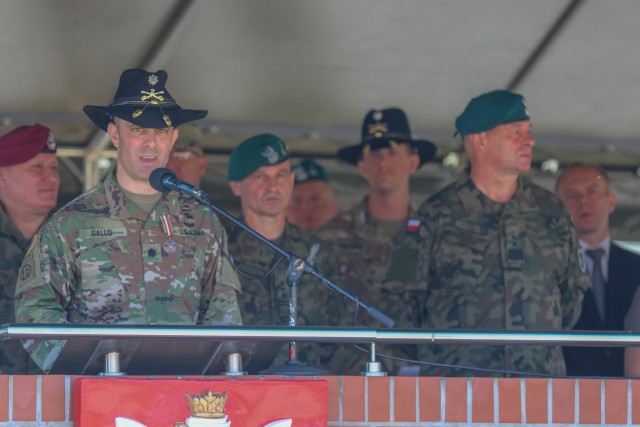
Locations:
82;105;208;132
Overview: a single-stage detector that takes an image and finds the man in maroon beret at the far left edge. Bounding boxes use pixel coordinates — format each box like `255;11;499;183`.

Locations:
0;124;60;374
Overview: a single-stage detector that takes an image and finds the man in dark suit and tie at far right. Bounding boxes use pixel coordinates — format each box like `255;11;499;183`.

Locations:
556;163;640;376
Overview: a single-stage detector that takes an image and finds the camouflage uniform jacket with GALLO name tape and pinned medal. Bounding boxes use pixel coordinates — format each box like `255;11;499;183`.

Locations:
16;170;242;372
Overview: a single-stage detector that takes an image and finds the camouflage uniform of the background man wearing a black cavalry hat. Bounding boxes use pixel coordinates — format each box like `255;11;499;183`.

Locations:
318;197;424;375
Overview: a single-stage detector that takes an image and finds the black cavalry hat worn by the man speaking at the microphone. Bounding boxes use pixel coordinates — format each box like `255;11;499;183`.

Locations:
82;68;207;132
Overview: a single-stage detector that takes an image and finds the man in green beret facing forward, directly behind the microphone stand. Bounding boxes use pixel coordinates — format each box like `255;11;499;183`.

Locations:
226;134;340;373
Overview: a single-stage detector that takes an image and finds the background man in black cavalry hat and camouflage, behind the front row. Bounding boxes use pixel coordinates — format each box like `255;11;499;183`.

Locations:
318;108;436;374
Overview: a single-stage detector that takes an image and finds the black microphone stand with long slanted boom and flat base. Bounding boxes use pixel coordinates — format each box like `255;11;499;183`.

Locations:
192;192;395;375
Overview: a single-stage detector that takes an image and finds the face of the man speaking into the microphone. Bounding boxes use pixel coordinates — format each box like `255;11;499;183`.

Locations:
107;119;178;192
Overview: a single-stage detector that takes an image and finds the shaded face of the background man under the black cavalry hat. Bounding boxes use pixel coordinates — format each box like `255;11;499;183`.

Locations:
358;144;420;193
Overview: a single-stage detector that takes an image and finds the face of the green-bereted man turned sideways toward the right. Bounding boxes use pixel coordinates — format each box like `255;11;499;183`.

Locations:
484;120;535;174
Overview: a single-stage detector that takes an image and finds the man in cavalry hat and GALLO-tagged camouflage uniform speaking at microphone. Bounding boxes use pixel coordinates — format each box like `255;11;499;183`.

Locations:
16;69;241;372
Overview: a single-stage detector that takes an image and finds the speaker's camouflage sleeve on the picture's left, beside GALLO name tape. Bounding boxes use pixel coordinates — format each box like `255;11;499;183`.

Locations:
15;224;74;373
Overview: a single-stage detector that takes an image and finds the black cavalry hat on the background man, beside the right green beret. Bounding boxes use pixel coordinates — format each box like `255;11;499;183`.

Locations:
337;108;436;166
